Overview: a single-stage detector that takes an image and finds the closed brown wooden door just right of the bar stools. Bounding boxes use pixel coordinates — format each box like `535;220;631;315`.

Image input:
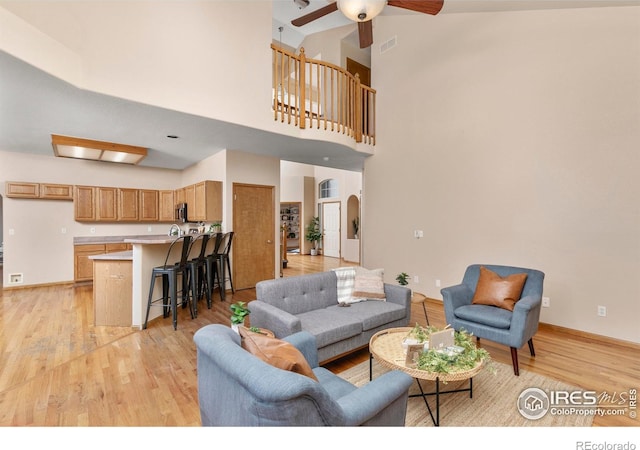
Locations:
231;183;276;289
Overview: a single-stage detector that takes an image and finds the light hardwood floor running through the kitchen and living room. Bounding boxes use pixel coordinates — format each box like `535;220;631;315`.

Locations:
0;255;640;426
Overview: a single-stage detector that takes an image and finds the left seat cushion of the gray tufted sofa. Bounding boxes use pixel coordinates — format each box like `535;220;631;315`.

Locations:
298;305;362;348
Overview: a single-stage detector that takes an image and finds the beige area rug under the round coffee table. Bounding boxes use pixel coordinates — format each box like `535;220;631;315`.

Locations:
339;360;593;427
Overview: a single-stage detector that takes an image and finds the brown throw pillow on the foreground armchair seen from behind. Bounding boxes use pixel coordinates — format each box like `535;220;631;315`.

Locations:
238;326;318;381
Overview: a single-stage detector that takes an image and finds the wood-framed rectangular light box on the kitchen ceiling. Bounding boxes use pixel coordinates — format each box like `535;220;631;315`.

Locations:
51;134;147;164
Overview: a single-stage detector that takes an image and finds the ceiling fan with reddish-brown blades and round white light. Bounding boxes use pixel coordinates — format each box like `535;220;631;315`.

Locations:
291;0;444;48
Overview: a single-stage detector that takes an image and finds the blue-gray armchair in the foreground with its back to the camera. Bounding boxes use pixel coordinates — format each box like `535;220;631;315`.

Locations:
194;324;413;426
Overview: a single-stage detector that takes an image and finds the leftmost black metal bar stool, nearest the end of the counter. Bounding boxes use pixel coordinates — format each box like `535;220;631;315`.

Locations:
143;235;194;330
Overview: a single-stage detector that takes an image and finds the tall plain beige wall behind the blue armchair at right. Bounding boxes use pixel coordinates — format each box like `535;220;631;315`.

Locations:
362;7;640;342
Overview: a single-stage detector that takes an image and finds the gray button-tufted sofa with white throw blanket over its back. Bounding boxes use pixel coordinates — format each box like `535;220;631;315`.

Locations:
248;271;411;363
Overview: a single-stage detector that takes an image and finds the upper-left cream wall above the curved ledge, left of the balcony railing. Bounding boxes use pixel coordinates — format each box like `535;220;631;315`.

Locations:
0;0;274;129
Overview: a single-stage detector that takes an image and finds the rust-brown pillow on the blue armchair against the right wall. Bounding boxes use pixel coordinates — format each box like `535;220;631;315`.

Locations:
471;266;527;311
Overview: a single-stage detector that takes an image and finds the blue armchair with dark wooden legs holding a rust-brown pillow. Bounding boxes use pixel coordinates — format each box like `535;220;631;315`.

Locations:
440;264;544;376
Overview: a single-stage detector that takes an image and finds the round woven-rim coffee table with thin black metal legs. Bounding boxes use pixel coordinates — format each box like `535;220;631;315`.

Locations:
369;327;482;426
